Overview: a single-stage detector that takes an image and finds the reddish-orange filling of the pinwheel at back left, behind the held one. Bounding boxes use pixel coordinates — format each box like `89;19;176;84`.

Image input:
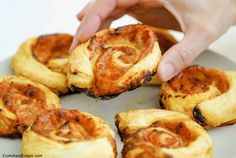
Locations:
32;34;73;64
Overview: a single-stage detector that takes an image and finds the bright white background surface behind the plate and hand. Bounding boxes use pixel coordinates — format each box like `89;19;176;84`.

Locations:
0;0;236;61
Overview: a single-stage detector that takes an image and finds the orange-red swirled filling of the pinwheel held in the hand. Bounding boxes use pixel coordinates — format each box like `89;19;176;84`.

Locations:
88;25;156;96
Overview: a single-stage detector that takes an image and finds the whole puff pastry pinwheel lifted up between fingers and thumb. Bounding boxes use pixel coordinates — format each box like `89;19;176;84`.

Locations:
68;25;161;99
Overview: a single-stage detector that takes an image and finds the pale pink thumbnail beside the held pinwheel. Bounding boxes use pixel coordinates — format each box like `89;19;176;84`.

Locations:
161;62;175;81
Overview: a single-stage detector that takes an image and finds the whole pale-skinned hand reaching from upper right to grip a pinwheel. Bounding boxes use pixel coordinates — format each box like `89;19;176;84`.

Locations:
70;0;236;81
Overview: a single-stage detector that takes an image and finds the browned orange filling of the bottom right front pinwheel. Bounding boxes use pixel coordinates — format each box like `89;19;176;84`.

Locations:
122;121;197;158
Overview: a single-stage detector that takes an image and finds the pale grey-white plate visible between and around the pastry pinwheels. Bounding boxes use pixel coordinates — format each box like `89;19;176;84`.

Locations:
0;51;236;158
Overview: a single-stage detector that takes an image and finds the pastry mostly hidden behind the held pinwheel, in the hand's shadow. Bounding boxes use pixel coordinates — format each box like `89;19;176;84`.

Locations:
148;26;177;86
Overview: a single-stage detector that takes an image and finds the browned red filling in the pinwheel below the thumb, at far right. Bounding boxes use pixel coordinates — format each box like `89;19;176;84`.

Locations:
168;66;229;94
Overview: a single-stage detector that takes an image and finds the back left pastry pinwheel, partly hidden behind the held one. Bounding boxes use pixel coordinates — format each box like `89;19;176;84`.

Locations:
12;34;73;94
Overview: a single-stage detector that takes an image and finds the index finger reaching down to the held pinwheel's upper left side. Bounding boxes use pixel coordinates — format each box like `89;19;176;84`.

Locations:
70;0;140;51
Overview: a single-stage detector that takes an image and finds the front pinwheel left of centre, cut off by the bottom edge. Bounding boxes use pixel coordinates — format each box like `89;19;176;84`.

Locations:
22;109;117;158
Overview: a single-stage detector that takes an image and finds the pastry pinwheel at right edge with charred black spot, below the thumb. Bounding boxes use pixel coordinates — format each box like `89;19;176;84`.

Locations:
160;66;236;128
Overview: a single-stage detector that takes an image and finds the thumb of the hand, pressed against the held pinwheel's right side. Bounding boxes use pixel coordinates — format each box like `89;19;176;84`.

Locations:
158;30;212;81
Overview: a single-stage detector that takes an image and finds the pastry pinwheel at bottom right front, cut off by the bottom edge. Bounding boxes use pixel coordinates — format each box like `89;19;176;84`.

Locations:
116;109;212;158
